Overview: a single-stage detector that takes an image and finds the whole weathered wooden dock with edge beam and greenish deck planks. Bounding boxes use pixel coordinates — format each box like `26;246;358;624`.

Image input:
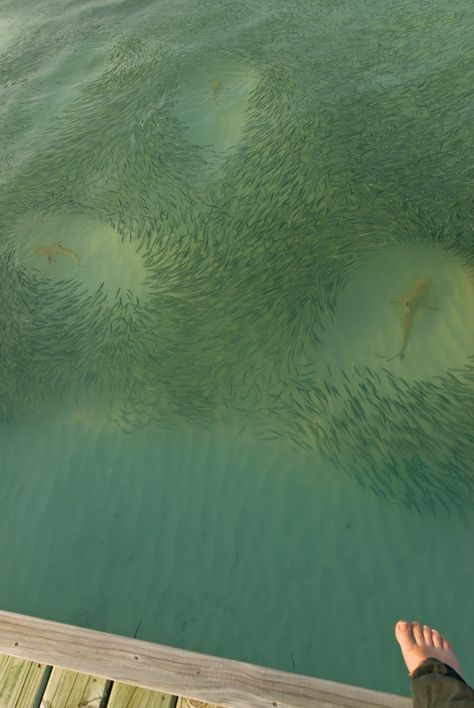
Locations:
0;612;411;708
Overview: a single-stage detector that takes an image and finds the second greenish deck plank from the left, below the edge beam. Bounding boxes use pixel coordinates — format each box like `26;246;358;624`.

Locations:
41;667;106;708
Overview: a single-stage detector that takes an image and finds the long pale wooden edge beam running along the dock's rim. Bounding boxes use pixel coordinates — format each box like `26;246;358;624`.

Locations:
0;611;411;708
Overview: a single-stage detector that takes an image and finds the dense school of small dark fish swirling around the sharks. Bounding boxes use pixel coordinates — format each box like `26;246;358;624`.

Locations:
0;3;474;510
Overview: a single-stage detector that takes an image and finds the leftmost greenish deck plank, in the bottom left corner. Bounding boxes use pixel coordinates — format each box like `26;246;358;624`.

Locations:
0;656;46;708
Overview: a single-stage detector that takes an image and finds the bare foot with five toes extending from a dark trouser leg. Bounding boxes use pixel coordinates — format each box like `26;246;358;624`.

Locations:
395;620;461;676
